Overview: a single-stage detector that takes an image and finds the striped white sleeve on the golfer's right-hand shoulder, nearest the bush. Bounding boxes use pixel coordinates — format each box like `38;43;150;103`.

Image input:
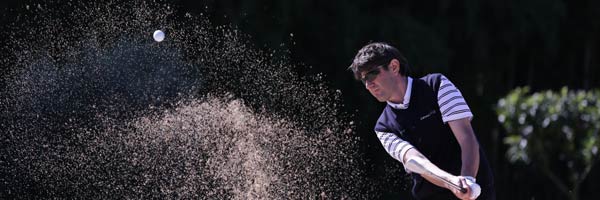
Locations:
438;75;473;123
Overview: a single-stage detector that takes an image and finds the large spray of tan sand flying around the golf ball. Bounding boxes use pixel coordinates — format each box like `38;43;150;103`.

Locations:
0;0;374;199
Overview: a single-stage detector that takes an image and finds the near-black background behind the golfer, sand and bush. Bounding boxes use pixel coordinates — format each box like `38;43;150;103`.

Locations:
0;0;600;199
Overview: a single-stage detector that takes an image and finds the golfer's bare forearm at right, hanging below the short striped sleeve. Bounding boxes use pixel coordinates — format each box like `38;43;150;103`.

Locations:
448;118;479;177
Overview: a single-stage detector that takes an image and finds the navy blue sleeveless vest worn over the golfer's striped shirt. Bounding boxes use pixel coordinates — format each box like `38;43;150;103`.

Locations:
375;74;493;199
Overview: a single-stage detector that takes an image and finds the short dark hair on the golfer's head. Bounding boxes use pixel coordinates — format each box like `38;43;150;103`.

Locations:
348;42;410;79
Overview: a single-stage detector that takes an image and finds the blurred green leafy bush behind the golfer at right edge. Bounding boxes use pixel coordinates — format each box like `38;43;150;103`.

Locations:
496;87;600;199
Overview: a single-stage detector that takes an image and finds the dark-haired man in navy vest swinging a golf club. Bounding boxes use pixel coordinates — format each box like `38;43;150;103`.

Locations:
350;43;495;199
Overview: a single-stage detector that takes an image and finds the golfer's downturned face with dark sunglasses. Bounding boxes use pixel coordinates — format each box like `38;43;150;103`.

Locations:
361;63;398;102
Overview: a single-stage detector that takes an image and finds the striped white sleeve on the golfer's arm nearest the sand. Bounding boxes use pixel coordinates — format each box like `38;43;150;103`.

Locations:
375;131;414;173
